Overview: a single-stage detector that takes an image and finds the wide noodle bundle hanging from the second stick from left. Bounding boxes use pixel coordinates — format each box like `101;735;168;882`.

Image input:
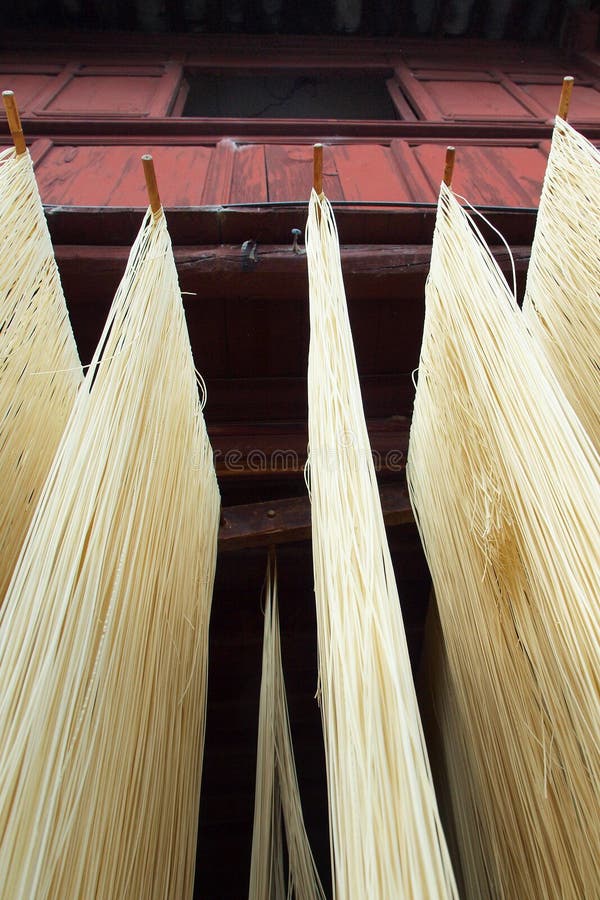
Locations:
0;204;219;900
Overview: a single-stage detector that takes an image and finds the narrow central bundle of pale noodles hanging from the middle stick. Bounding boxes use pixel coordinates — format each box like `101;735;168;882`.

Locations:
306;192;456;900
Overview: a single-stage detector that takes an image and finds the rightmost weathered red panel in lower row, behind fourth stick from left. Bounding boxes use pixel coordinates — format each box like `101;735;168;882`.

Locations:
413;144;546;207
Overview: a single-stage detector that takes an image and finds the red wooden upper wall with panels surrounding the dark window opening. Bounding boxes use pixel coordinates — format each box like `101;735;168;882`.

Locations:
0;36;600;206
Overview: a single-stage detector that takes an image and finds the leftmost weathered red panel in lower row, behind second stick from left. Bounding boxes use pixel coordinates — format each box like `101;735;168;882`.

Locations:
36;145;213;206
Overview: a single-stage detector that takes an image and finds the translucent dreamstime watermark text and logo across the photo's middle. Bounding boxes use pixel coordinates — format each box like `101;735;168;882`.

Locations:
213;431;405;474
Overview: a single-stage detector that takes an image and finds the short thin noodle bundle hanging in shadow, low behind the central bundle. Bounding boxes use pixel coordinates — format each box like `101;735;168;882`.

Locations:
248;555;325;900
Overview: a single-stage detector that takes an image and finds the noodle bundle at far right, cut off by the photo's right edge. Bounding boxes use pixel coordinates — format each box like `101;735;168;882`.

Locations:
523;118;600;449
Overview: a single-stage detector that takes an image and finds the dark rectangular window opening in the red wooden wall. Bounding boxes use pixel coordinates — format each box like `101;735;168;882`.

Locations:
183;73;397;119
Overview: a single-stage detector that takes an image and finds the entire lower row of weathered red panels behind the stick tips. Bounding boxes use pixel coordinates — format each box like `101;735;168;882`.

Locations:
32;140;547;209
